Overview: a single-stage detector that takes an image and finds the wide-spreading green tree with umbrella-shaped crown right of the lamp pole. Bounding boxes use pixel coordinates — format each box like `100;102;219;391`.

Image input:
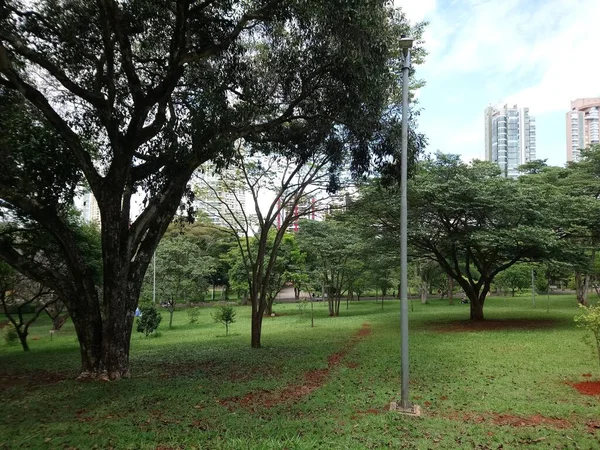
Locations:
360;154;560;320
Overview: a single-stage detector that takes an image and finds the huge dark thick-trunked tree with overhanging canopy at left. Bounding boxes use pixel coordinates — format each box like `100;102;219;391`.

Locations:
0;0;421;380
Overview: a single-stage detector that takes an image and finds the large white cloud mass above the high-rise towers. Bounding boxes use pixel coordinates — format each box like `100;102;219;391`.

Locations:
424;0;600;113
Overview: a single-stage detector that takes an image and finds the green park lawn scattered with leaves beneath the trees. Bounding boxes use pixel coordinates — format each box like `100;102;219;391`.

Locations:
0;296;600;450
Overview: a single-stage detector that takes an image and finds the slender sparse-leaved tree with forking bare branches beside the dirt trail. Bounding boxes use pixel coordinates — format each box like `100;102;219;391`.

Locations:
198;149;345;348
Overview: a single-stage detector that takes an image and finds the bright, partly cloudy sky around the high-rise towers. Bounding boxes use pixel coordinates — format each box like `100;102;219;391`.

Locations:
394;0;600;166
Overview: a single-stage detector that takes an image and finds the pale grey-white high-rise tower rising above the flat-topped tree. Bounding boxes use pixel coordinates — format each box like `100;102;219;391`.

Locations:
484;105;536;178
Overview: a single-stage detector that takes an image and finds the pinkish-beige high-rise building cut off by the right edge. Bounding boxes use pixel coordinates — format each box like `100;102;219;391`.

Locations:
567;98;600;161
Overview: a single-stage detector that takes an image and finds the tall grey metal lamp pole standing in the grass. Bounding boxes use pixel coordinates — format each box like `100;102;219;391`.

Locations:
400;44;412;410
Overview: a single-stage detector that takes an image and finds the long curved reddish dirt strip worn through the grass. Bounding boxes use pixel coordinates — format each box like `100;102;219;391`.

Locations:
219;323;372;411
